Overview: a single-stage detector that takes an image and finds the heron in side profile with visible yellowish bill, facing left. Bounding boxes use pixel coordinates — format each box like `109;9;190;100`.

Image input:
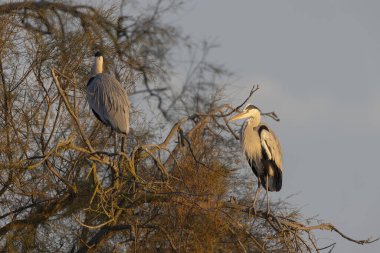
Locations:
230;104;282;212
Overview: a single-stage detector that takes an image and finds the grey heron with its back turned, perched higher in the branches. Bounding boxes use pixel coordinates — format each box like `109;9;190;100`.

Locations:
87;52;130;135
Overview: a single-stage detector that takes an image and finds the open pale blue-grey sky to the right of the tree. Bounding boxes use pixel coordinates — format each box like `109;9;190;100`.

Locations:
171;0;380;253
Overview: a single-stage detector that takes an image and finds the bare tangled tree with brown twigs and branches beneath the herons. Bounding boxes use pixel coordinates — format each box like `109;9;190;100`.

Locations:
0;0;372;252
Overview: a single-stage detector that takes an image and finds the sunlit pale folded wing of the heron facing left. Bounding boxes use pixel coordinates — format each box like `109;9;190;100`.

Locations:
260;126;282;170
